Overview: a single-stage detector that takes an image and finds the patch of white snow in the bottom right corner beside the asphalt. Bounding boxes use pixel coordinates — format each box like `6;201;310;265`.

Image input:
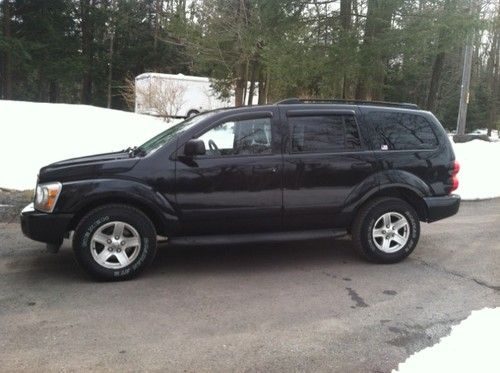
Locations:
393;308;500;373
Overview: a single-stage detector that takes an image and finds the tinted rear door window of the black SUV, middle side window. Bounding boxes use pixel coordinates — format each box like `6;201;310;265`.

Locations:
288;115;360;153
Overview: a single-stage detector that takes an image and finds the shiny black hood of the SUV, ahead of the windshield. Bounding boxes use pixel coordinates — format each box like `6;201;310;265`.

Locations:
38;151;139;183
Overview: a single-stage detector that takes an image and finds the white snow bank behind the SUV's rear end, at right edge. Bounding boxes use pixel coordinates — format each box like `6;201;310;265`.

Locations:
452;140;500;200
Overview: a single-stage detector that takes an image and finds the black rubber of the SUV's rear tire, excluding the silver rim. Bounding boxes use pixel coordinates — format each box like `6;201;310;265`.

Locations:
362;201;420;263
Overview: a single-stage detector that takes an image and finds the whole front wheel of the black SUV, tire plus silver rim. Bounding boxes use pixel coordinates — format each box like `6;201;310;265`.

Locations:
73;205;156;281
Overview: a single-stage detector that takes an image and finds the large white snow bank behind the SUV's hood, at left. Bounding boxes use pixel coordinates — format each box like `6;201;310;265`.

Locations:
0;100;178;189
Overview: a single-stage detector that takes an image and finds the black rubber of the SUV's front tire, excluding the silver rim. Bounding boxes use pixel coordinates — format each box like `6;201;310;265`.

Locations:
73;207;156;280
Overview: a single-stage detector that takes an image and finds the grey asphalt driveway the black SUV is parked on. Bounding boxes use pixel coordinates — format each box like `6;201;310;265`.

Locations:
0;199;500;372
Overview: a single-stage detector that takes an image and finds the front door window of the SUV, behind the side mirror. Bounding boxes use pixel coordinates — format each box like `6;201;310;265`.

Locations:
199;118;272;156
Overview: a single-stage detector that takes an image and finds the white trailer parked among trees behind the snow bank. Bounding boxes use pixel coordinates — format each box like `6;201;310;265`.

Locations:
135;73;258;117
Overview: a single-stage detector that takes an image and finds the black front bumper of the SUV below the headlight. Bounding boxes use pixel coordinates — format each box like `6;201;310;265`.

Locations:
21;203;73;245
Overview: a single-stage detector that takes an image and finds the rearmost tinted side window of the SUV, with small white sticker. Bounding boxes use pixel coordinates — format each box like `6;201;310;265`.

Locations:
367;111;438;150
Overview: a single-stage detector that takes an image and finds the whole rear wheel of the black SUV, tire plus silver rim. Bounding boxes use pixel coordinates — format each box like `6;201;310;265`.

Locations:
352;197;420;264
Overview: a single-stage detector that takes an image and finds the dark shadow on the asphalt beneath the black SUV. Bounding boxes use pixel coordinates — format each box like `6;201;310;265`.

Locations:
4;234;362;283
